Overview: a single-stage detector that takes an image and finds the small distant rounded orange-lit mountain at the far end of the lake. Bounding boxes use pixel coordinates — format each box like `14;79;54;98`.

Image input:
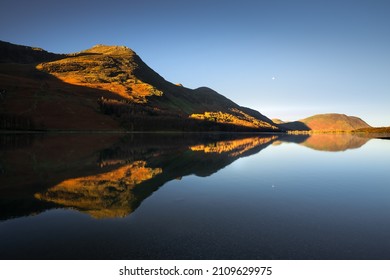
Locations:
277;114;370;131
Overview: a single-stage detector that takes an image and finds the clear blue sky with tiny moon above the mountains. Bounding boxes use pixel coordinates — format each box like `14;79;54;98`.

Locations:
0;0;390;126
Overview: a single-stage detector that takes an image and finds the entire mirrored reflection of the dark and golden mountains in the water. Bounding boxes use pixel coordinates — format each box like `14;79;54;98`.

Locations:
0;134;368;220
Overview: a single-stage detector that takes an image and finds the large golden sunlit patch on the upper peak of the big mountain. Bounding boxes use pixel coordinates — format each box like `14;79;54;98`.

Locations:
36;45;163;103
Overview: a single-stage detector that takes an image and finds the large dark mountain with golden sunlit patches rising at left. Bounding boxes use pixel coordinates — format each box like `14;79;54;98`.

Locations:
0;42;279;131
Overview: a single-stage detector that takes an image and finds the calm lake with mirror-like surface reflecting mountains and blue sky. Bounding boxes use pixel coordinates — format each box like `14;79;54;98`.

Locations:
0;133;390;260
